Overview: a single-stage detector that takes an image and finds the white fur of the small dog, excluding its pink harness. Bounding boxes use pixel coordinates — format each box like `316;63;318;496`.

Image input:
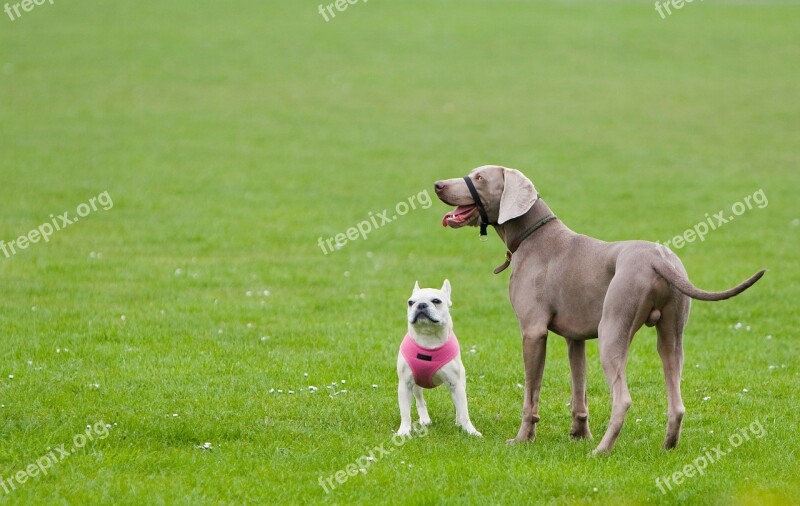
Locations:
397;280;481;436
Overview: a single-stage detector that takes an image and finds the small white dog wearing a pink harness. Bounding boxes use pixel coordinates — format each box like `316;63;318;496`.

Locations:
397;279;481;436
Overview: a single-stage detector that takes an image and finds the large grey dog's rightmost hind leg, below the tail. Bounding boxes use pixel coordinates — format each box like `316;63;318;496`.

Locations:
656;295;691;450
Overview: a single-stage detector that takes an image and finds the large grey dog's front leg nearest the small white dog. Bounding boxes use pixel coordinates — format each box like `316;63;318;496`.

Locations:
506;327;547;444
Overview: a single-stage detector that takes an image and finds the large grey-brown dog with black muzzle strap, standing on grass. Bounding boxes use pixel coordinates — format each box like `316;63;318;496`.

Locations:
434;165;764;453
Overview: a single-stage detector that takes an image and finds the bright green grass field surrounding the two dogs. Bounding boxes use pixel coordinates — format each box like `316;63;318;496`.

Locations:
0;0;800;504
